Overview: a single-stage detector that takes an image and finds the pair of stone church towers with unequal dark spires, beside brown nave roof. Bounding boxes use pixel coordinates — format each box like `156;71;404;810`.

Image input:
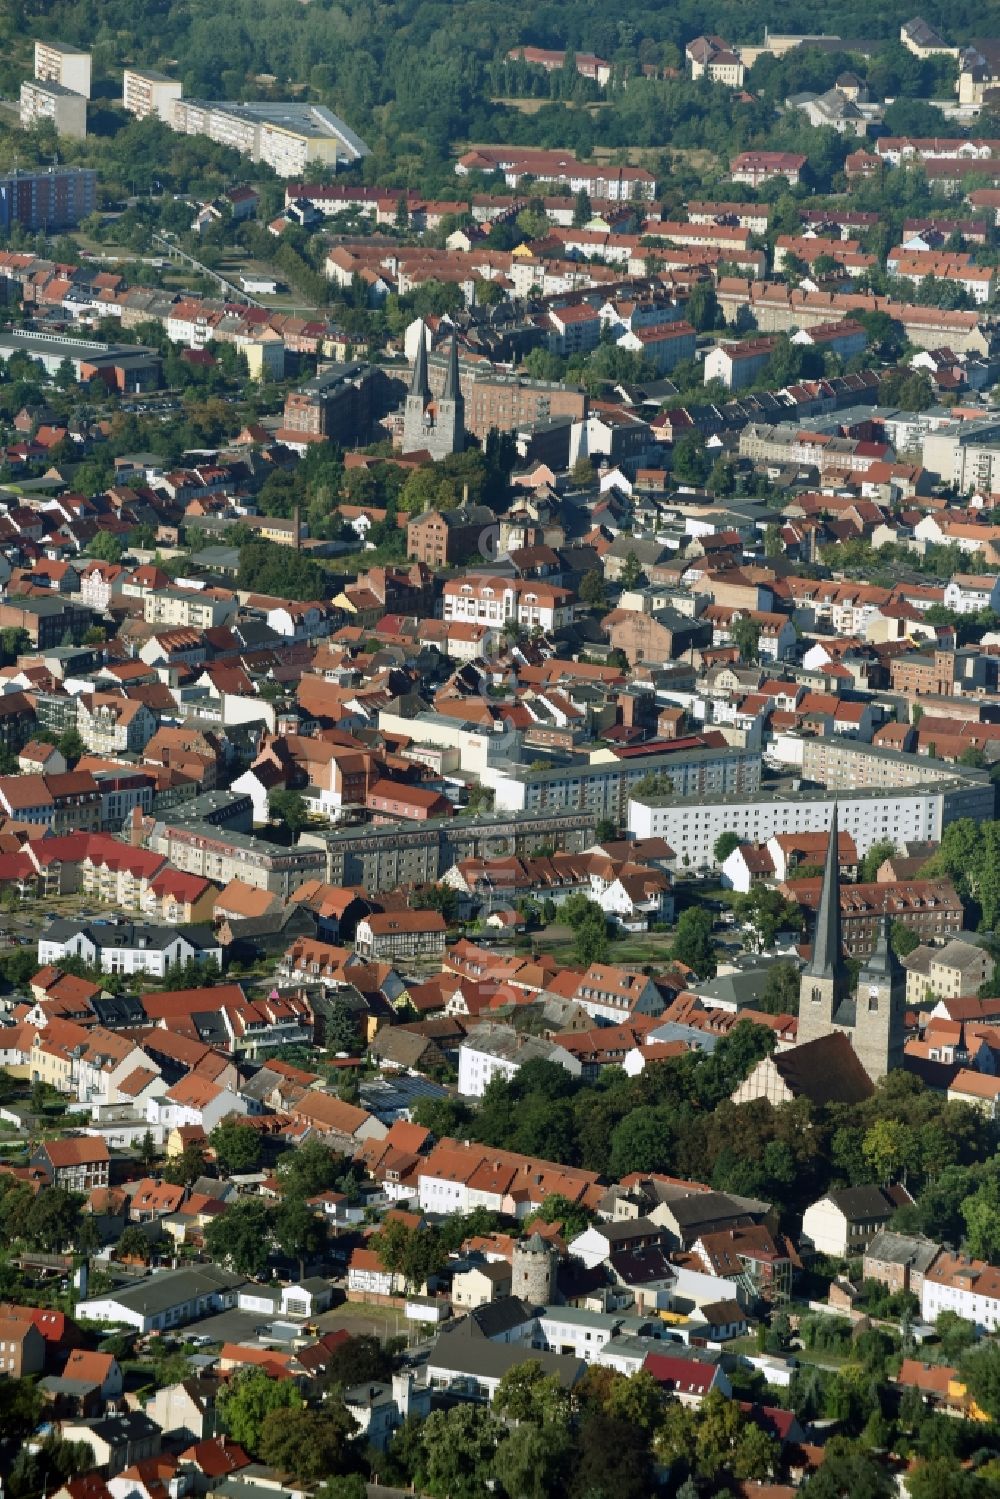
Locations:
798;803;906;1082
